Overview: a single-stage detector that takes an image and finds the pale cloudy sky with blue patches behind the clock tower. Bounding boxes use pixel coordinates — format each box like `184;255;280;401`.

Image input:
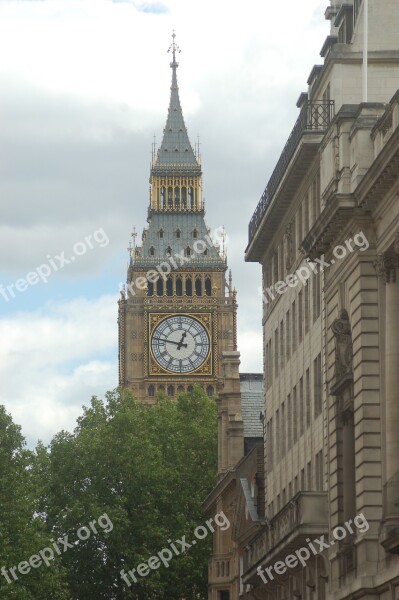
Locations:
0;0;328;445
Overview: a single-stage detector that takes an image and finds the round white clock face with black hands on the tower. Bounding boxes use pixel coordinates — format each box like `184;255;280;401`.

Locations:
151;315;210;373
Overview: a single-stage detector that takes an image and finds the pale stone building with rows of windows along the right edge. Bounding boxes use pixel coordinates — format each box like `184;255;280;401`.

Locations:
242;0;399;600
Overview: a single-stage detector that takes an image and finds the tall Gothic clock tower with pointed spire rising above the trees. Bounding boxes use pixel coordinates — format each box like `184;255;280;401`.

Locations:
118;34;237;403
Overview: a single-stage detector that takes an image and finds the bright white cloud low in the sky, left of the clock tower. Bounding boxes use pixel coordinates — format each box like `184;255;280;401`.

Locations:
0;296;118;443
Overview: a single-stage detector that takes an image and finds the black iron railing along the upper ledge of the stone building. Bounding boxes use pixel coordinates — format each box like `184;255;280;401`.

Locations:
248;100;334;243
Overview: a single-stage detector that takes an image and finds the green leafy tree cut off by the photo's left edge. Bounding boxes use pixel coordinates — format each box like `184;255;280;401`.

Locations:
0;406;70;600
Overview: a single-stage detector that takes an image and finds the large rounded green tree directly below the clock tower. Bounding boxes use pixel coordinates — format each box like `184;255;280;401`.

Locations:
40;387;217;600
